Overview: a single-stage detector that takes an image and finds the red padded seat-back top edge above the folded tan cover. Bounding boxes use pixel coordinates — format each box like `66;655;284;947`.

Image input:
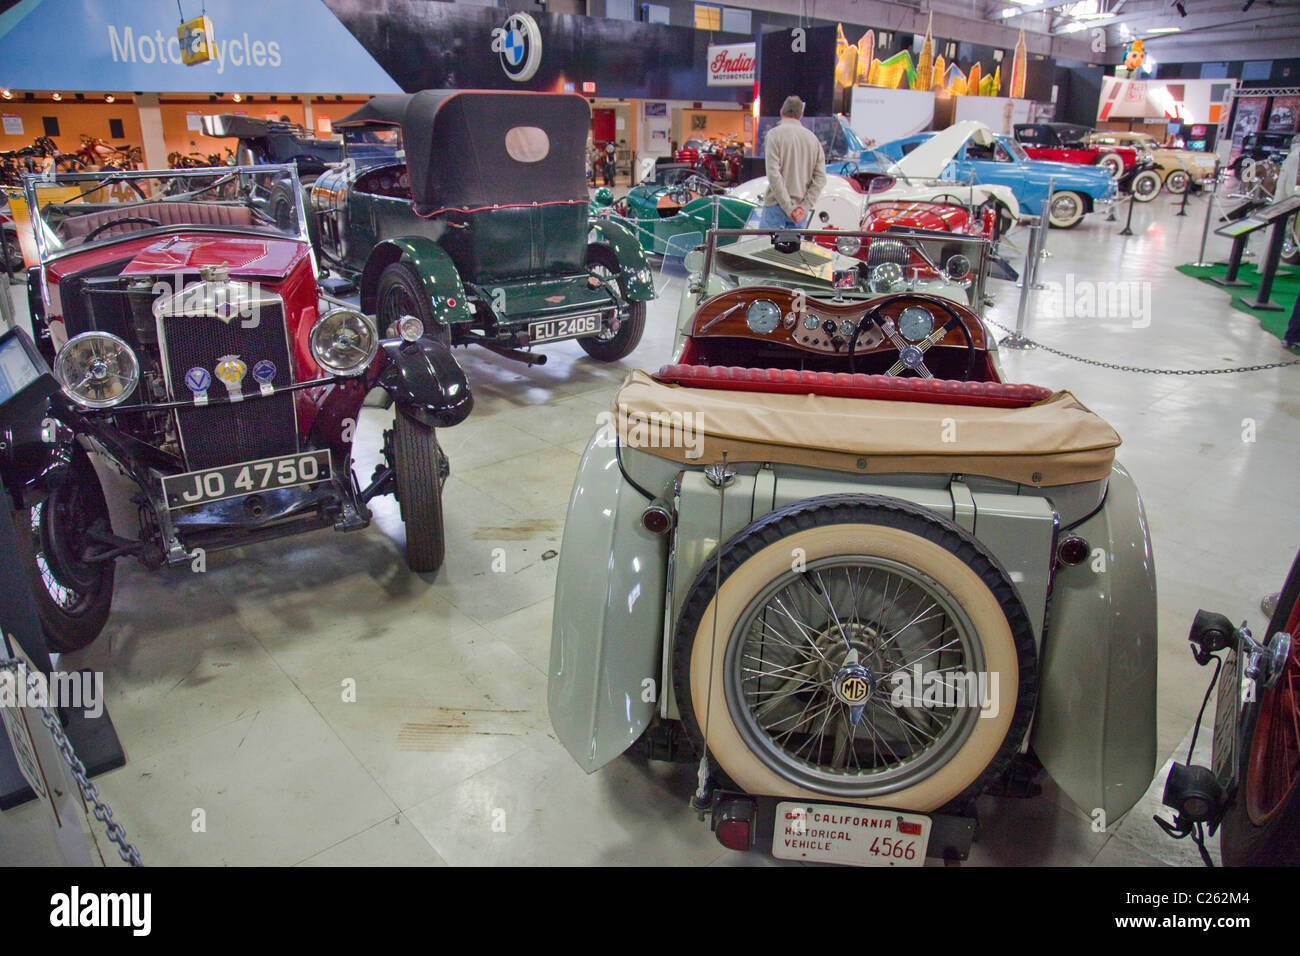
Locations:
654;365;1052;408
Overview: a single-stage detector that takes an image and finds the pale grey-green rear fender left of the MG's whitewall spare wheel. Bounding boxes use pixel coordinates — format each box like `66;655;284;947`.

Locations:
546;429;680;773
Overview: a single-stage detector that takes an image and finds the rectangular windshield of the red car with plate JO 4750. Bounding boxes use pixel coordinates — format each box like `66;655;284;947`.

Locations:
23;165;307;261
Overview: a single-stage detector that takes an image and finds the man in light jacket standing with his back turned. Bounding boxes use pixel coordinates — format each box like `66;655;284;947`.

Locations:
749;96;826;229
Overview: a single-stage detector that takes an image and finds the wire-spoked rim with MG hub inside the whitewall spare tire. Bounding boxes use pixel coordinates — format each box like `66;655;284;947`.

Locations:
725;555;983;793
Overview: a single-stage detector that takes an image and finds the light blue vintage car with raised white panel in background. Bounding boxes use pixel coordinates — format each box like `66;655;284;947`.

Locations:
827;120;1115;229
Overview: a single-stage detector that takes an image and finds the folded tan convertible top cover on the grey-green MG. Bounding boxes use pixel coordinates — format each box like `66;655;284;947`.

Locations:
614;372;1119;485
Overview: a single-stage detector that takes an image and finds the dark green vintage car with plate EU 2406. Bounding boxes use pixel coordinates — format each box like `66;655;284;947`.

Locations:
311;90;654;364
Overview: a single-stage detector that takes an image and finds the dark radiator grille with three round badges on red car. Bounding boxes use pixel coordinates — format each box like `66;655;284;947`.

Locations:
163;303;298;471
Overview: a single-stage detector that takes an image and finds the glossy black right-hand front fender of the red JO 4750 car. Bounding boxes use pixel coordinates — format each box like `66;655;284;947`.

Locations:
378;336;475;428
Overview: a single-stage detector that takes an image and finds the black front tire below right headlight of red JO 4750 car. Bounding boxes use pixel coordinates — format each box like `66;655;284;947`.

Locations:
393;408;446;574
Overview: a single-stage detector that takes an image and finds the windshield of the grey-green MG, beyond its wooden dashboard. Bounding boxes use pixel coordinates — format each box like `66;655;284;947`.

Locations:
686;229;989;313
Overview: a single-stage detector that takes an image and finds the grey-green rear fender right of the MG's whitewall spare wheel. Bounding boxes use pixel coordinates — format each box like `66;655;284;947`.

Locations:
1030;463;1157;826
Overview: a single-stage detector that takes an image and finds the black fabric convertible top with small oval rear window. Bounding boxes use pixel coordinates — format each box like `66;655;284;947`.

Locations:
334;90;592;216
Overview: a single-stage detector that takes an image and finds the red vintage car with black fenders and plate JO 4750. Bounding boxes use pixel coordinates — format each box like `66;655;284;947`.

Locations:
17;165;473;650
